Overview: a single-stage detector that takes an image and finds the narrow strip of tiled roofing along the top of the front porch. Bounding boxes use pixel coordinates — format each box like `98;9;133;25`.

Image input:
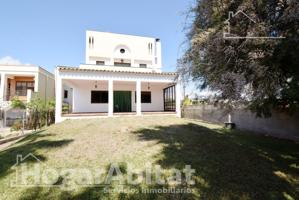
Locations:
57;66;177;76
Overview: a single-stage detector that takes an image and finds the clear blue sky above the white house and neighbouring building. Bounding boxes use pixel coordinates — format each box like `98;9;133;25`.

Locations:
0;0;193;72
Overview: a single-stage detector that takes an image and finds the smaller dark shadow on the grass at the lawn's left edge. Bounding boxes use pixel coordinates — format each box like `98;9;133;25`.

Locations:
0;132;73;178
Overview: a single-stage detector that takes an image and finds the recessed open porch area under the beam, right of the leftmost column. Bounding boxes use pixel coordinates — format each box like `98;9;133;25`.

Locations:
62;80;175;117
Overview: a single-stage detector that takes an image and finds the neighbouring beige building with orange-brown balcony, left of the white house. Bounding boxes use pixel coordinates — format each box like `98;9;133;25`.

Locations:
0;64;55;109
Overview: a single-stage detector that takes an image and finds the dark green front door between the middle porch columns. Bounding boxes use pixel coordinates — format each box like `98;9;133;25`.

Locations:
113;91;132;112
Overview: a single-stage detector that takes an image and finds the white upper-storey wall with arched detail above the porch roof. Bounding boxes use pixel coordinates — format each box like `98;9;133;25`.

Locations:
86;31;162;69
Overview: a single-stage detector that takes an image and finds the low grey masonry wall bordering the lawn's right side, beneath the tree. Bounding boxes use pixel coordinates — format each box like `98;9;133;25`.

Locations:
182;104;299;140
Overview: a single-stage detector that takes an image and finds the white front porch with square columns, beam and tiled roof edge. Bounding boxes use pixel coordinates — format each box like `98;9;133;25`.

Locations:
56;67;180;122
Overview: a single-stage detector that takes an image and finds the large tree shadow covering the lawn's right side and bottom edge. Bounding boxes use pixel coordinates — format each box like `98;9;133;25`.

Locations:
14;123;299;199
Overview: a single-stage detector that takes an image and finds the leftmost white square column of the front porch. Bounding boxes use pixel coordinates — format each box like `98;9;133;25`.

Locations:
55;70;62;123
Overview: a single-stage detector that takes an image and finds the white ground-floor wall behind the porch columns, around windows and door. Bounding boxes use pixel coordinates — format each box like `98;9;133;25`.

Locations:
73;81;166;112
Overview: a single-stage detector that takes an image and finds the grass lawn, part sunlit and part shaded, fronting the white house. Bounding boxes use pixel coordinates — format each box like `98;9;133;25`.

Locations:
0;116;299;200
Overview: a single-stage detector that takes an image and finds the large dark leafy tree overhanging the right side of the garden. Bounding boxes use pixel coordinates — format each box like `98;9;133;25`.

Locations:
179;0;299;116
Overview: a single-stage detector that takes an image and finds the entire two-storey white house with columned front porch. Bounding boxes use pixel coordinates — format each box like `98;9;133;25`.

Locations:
55;31;181;122
